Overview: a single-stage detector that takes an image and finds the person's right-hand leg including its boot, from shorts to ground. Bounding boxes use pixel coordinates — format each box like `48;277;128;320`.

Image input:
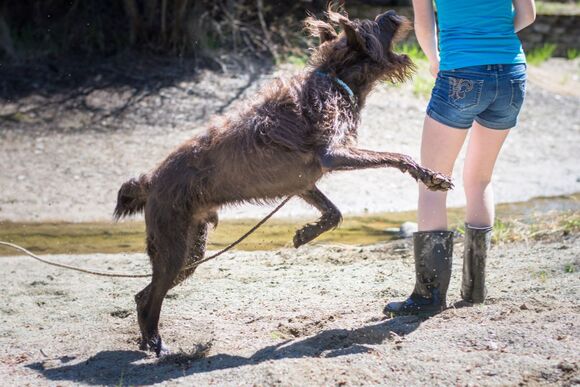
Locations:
461;122;509;303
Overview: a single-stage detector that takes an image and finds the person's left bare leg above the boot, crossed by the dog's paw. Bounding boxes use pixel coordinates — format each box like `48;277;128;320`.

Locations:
418;116;467;231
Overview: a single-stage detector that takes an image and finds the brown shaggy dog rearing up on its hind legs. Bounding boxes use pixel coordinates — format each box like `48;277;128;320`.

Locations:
115;6;452;356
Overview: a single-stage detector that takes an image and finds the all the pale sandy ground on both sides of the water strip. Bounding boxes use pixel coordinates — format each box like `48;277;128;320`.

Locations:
0;56;580;386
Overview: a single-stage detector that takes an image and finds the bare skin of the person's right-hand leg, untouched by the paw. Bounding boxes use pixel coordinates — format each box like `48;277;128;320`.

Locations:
463;123;509;227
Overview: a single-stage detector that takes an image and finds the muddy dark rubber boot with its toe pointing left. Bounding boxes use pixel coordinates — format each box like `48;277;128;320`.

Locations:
383;231;453;316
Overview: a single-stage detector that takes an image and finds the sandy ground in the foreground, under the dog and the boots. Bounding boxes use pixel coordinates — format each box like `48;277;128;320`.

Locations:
0;236;580;386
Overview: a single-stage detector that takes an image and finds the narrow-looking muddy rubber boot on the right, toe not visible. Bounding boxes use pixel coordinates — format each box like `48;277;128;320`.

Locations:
461;223;492;304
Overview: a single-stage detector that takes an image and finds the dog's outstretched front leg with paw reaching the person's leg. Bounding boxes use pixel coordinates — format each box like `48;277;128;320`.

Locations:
319;147;453;191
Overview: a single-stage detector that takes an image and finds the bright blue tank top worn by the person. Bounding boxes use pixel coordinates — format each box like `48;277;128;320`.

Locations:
435;0;526;70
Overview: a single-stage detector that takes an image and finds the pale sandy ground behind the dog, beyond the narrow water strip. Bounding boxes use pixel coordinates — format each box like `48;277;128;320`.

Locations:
0;59;580;221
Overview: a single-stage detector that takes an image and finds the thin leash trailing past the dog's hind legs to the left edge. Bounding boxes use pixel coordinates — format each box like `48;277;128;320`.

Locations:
0;196;292;278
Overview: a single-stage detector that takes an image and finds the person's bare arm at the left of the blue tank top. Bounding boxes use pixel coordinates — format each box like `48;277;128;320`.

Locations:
413;0;440;77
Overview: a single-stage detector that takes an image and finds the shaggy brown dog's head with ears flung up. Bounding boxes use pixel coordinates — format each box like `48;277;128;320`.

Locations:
305;6;413;82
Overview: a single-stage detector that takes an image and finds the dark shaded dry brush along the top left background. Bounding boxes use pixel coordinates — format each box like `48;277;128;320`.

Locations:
0;0;323;60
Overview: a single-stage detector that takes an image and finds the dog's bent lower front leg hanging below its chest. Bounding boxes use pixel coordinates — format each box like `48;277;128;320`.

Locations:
294;186;342;248
